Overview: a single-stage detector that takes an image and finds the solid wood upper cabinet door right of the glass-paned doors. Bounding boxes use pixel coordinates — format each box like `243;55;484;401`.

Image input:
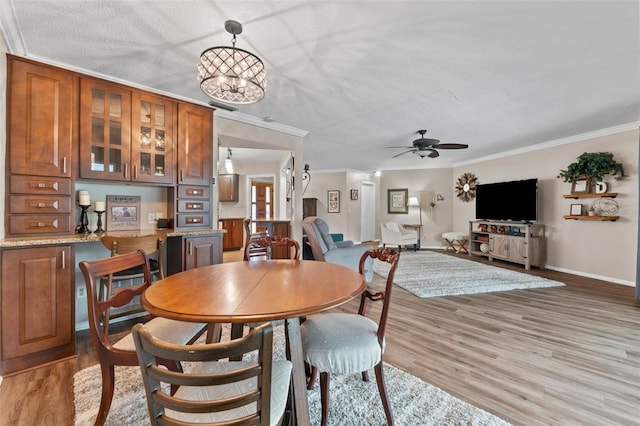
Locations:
178;103;213;186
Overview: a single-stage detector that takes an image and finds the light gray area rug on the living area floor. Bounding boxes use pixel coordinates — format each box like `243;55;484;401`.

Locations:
373;251;564;297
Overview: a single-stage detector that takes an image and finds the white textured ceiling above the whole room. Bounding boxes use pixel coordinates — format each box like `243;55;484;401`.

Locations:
0;0;640;171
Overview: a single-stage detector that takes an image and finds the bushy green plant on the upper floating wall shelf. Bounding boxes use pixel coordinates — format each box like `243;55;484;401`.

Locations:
558;152;624;183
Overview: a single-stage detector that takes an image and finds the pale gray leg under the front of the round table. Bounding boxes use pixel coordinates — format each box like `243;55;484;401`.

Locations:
285;318;310;426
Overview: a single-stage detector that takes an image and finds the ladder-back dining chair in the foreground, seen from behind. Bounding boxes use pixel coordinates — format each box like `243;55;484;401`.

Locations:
133;323;292;426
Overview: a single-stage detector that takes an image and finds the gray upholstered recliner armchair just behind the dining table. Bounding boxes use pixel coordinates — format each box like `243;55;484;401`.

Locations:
302;216;373;282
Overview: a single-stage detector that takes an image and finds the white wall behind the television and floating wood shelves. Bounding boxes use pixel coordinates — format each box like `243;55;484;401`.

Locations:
452;126;639;285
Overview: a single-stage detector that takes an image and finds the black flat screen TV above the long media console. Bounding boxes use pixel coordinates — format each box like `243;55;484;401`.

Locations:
476;179;538;222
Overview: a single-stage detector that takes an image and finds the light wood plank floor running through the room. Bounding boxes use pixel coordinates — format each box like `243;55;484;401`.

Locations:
0;248;640;425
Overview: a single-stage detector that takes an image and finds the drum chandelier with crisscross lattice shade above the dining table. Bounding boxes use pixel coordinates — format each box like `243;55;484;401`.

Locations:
198;20;267;104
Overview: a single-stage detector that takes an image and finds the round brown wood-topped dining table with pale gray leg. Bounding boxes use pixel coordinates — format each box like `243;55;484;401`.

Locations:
141;259;366;426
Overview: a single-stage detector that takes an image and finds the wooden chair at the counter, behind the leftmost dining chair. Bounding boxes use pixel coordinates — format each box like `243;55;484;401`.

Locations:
99;234;166;329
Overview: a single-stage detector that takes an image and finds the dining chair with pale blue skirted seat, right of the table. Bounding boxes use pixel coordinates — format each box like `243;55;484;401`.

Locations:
301;247;400;425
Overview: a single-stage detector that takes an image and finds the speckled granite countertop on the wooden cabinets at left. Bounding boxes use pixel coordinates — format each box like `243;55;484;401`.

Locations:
0;229;227;248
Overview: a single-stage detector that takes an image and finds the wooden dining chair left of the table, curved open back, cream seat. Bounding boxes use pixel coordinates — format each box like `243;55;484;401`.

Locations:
79;250;208;425
